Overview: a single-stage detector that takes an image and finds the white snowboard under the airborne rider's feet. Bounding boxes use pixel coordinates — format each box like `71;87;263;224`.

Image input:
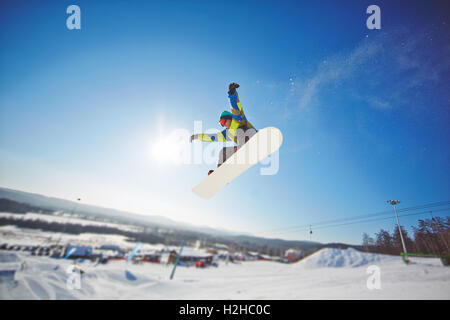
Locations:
192;127;283;199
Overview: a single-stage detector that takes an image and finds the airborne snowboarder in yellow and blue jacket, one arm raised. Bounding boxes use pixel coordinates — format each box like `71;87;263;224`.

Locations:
191;82;257;175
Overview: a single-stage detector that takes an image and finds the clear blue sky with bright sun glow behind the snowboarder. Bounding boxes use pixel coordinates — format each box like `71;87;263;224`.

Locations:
0;1;450;243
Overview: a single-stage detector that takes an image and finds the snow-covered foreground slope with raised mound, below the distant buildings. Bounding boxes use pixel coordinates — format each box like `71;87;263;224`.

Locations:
0;249;450;300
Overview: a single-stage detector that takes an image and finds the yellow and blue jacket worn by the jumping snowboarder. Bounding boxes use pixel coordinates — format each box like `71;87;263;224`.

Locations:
197;91;255;144
